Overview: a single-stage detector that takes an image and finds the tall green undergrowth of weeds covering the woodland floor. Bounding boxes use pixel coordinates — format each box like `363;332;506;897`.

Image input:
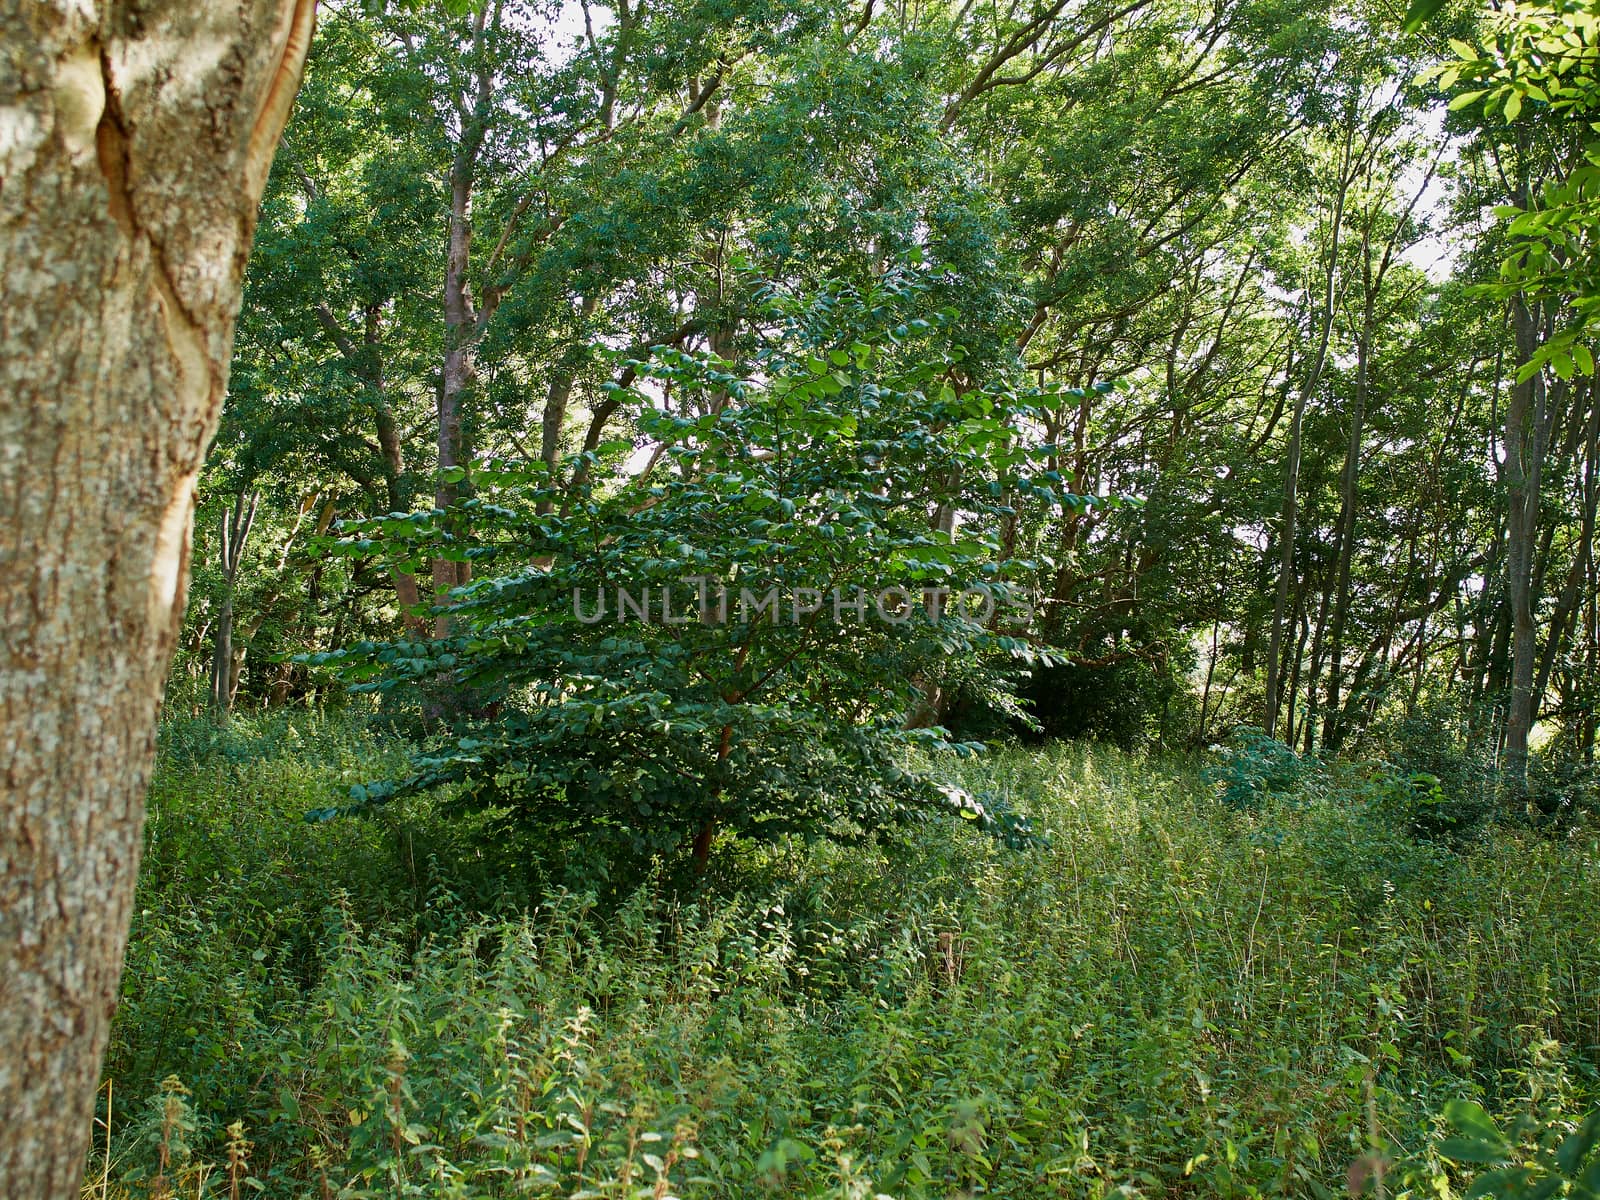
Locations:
85;715;1600;1200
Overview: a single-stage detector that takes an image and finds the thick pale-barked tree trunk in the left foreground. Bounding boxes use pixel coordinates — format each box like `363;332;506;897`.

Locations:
0;0;312;1200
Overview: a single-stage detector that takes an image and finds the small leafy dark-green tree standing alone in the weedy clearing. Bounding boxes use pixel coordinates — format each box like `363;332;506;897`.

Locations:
312;275;1102;864
